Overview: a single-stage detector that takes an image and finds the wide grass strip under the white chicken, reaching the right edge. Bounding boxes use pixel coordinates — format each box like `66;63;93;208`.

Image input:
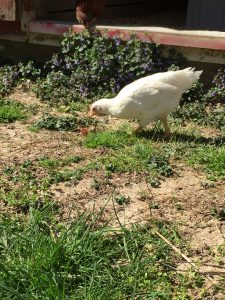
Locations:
84;123;225;180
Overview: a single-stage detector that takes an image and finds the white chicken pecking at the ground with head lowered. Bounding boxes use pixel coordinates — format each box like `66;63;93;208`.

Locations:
89;68;202;136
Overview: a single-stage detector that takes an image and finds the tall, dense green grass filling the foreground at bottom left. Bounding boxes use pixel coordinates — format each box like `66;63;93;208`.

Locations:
0;206;203;300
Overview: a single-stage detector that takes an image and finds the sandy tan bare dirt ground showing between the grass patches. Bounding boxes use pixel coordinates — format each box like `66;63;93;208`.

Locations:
0;92;225;299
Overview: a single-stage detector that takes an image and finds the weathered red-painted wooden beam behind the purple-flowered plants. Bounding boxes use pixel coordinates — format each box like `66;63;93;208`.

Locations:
29;21;225;50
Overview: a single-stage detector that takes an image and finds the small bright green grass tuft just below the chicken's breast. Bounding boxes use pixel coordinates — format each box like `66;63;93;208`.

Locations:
84;129;138;150
